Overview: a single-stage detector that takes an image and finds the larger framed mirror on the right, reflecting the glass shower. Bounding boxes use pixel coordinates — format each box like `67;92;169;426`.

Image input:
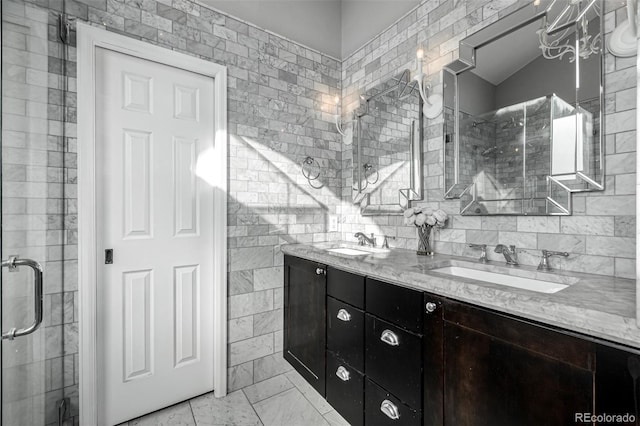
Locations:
443;0;604;215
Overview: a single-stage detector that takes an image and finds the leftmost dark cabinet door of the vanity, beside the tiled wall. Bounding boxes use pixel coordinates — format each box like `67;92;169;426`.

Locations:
284;256;326;396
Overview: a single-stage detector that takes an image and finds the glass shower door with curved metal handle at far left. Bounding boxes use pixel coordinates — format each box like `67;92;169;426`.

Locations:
1;0;69;426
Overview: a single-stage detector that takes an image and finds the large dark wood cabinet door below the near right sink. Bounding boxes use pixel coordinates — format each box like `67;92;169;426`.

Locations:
444;305;594;426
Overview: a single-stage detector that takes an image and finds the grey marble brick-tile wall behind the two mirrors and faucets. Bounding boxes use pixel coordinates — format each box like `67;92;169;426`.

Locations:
341;0;636;278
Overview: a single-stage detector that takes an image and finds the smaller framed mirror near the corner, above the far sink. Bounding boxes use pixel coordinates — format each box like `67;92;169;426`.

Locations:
353;70;423;215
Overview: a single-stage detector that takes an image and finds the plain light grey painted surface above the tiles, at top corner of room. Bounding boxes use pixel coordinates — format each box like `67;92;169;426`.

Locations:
200;0;420;59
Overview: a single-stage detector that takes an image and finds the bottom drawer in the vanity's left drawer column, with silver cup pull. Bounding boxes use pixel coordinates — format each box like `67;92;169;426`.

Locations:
326;352;364;426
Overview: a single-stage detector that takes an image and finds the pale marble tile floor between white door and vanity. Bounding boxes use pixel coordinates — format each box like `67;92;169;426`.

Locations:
119;370;349;426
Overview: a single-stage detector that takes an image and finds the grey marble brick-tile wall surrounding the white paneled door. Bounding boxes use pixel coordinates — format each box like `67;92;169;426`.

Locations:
13;0;342;423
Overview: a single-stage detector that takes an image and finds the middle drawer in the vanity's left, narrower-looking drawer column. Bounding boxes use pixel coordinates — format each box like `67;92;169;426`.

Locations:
327;297;364;371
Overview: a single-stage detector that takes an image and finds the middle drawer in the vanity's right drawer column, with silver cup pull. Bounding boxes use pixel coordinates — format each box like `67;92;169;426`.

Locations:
365;314;422;407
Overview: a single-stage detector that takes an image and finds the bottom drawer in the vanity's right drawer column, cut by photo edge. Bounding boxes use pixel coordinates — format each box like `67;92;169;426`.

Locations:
364;379;421;426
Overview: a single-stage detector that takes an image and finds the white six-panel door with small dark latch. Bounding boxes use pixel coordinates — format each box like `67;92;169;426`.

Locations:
95;48;214;425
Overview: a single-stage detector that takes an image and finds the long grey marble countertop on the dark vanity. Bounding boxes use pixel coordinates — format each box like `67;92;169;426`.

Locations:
282;242;640;348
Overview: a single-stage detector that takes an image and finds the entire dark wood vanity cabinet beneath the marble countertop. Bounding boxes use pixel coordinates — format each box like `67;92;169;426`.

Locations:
284;256;640;426
